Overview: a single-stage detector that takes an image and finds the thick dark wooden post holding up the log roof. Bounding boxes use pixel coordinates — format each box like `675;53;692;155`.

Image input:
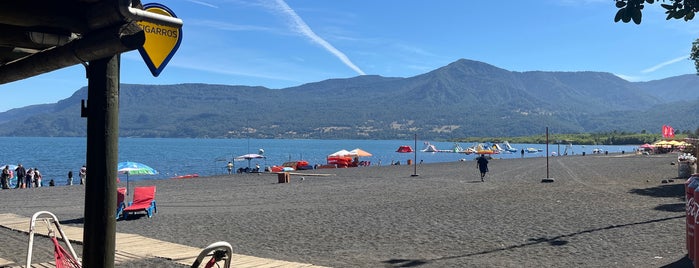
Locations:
82;55;120;268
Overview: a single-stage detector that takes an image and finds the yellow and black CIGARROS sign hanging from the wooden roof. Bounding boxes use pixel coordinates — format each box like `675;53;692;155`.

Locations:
138;3;182;77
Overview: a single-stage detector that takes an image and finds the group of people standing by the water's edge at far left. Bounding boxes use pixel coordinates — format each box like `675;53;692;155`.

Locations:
0;164;87;189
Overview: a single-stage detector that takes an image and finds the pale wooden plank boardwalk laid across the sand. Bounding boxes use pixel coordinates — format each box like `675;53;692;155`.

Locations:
0;213;322;268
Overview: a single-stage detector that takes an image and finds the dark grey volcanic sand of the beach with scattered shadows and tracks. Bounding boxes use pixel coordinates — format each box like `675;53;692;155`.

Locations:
0;154;689;267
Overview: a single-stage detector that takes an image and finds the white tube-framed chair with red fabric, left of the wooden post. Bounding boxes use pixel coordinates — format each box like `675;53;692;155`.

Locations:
25;211;80;268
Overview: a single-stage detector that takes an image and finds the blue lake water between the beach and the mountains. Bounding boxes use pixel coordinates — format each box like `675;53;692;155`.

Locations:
0;137;638;185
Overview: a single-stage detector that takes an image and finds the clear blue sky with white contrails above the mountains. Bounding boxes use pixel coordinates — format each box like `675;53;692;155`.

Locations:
0;0;699;111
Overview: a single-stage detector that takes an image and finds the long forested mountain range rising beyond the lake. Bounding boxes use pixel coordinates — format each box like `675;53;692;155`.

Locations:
0;59;699;139
